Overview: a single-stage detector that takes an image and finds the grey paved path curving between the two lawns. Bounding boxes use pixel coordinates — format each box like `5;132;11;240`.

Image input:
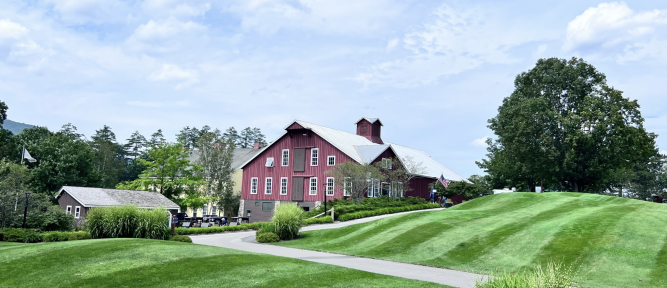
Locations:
191;209;485;288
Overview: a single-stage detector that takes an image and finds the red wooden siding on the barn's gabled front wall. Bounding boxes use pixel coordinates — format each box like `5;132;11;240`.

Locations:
241;129;354;201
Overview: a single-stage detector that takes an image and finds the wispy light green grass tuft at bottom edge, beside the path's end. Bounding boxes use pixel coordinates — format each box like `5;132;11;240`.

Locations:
475;262;575;288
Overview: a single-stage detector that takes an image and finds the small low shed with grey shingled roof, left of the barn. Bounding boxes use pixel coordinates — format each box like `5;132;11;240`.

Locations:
56;186;181;220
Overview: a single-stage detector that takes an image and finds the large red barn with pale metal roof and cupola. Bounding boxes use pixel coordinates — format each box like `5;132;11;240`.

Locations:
239;118;468;222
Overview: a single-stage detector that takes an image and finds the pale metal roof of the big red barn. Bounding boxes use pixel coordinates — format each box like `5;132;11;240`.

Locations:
241;118;470;182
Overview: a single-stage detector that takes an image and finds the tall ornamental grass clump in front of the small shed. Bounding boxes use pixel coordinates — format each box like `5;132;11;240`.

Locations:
86;205;170;240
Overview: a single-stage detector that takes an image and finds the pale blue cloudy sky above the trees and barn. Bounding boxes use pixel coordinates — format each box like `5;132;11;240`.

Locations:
0;0;667;176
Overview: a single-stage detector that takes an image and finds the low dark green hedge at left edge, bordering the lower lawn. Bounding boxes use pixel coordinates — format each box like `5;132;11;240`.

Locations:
0;228;92;243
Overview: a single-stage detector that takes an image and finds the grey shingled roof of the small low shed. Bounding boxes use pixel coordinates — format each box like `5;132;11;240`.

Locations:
56;186;180;209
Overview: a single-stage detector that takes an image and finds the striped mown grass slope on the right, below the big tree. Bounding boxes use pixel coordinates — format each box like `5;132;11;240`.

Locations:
276;193;667;287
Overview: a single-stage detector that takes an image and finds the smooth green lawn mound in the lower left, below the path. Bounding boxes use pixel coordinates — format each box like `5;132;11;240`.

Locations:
0;239;452;287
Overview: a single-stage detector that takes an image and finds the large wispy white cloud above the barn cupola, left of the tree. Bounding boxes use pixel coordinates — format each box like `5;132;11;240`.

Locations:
352;5;545;88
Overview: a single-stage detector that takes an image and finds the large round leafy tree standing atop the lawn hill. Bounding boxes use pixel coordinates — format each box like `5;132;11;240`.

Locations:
478;58;657;192
